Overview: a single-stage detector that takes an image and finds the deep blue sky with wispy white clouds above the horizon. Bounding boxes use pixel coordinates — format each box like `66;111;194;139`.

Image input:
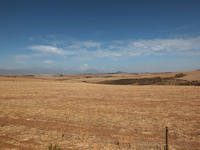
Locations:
0;0;200;72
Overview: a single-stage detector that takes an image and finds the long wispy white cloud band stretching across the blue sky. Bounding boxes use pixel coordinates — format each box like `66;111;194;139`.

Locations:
12;36;200;63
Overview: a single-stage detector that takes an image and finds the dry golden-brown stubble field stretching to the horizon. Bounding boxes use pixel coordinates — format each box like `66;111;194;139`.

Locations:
0;74;200;150
